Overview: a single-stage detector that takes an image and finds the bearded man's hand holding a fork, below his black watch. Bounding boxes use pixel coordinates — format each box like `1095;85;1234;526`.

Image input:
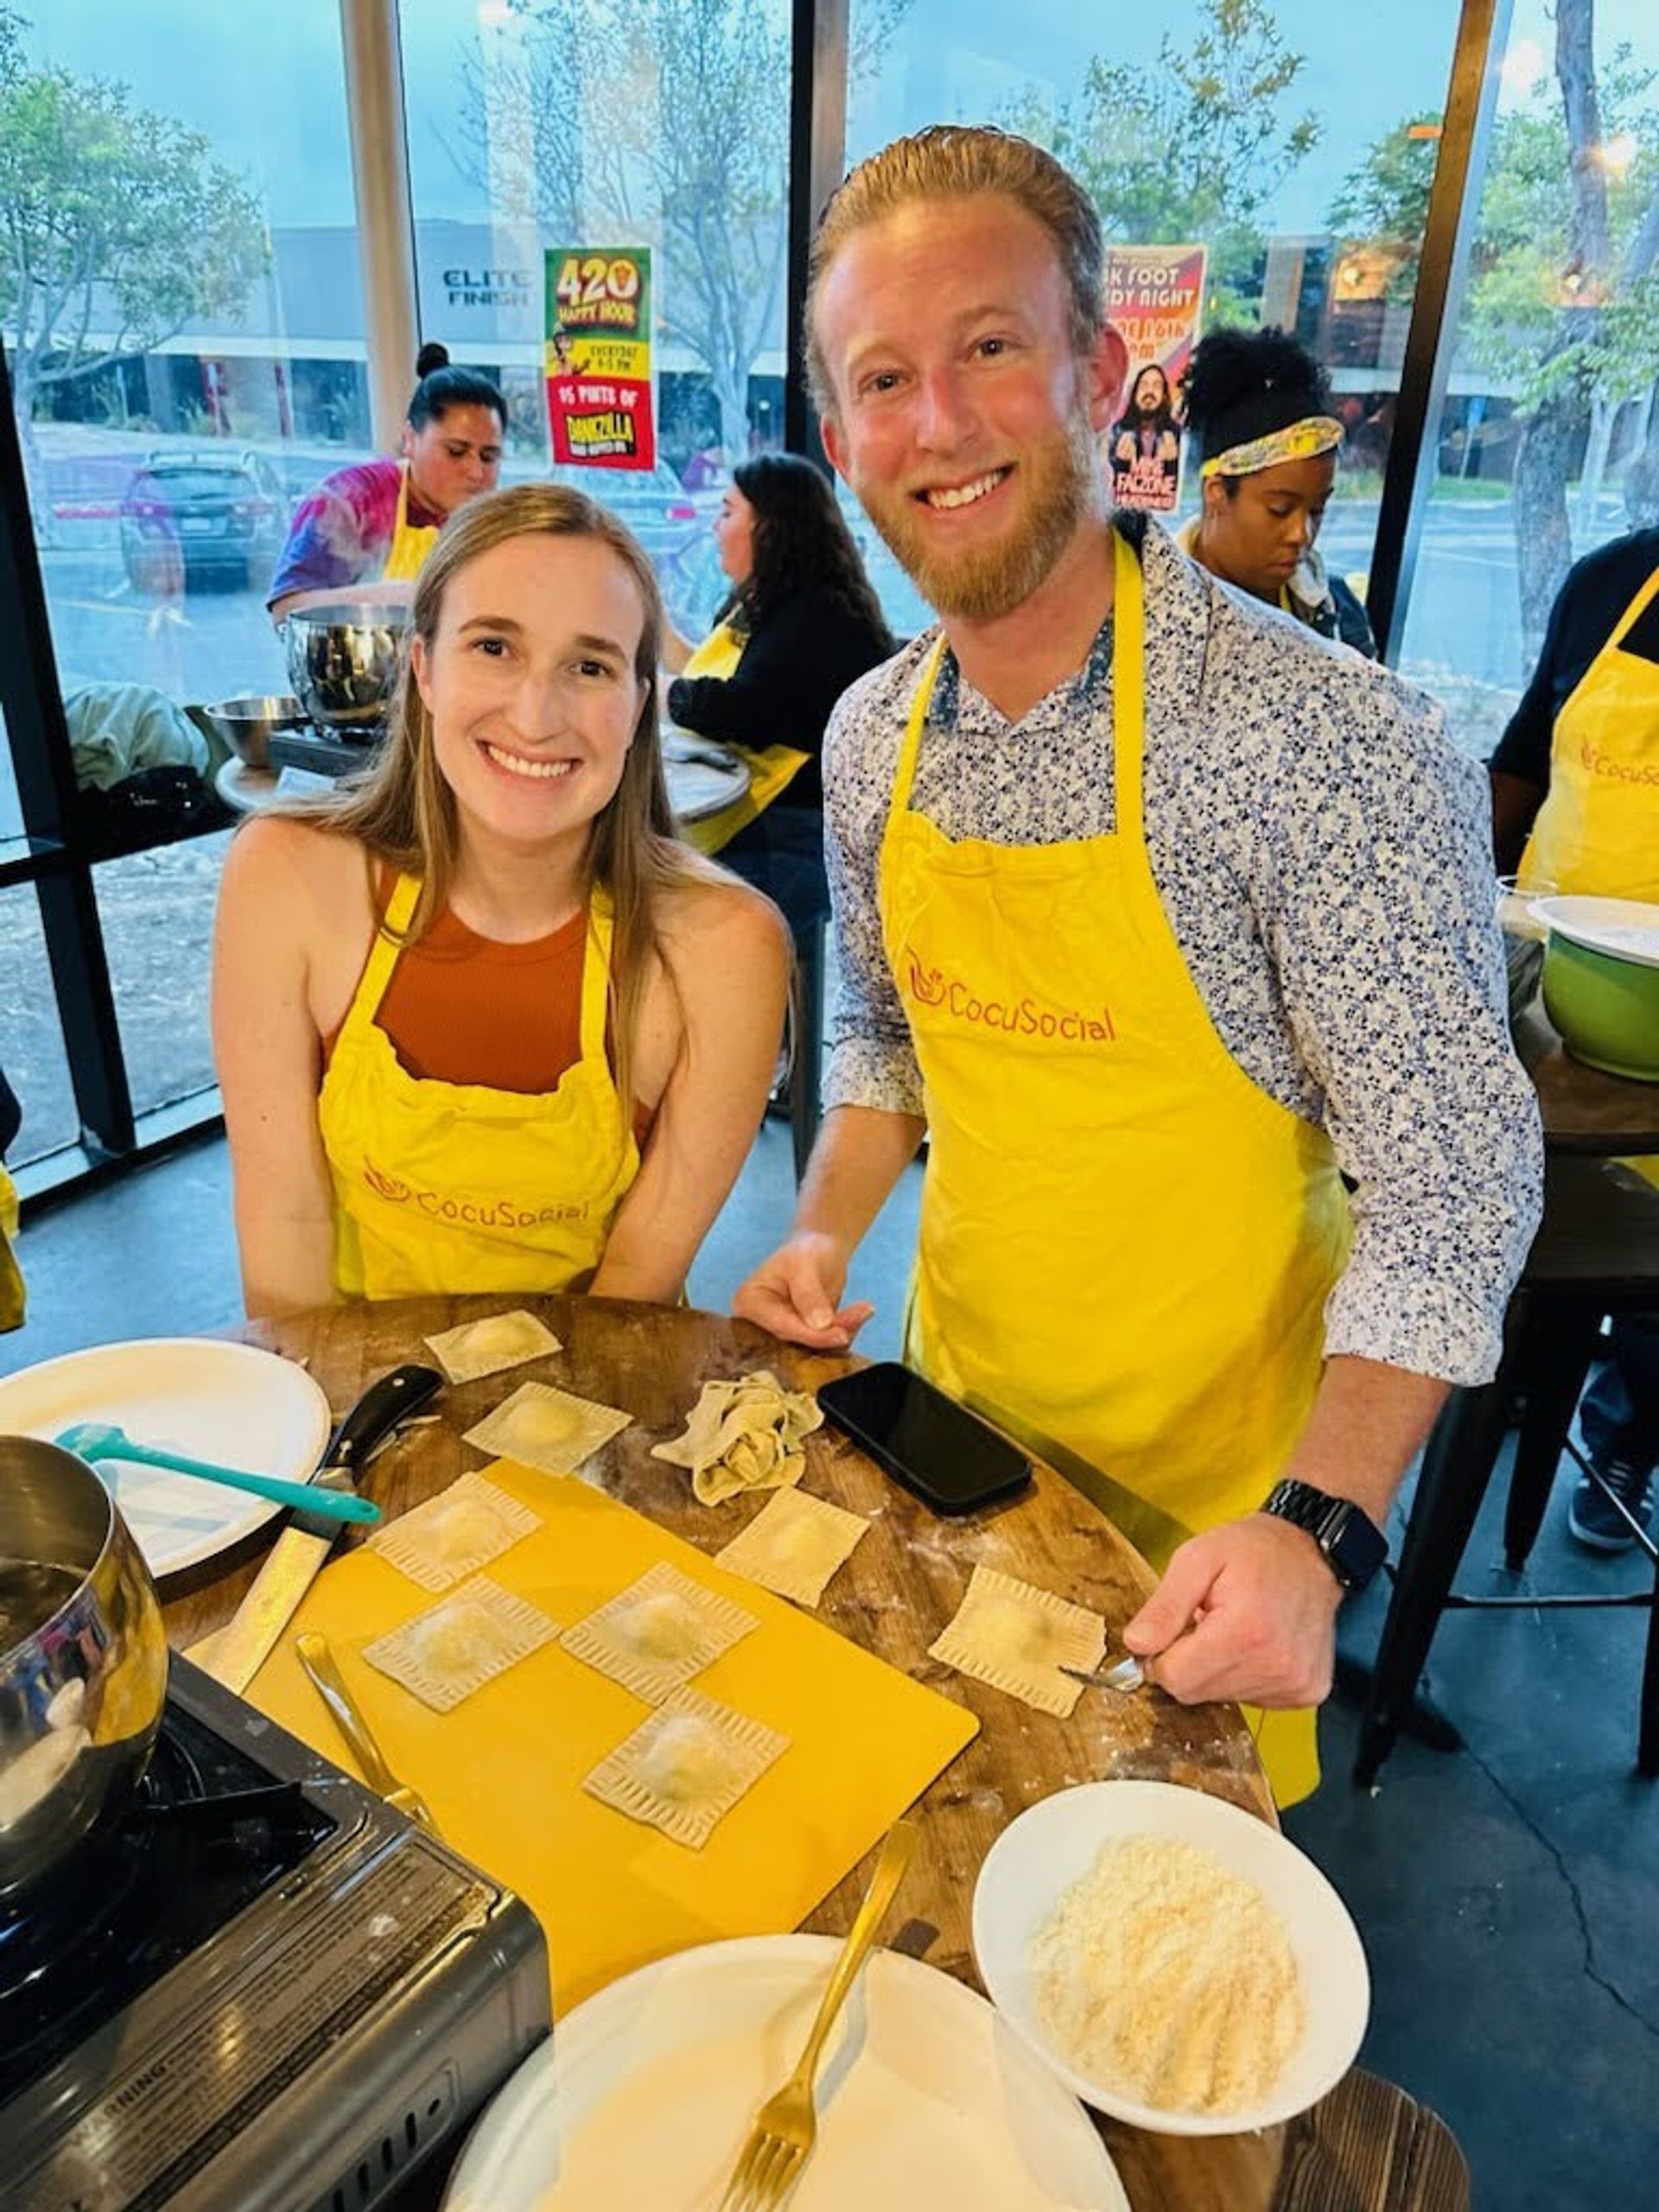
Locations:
1123;1513;1343;1707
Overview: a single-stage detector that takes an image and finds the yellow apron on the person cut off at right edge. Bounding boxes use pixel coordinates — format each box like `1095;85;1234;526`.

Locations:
1520;569;1659;900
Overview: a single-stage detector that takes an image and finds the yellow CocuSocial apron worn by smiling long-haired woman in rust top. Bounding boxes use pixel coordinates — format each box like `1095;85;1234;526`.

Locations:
316;876;639;1299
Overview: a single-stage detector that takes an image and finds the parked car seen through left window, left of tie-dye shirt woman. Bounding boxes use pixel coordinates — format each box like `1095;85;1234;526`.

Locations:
122;454;289;593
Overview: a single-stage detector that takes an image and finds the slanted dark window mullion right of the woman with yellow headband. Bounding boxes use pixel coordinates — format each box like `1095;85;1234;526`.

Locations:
1365;0;1513;668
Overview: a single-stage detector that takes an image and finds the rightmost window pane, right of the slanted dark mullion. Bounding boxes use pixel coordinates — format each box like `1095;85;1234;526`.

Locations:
1402;0;1659;759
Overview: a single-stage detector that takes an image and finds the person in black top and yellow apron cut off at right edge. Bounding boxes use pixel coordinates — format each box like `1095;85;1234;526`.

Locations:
1489;531;1659;1553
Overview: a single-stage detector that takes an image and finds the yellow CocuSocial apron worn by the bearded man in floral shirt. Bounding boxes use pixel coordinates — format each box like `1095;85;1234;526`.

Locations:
880;537;1347;1805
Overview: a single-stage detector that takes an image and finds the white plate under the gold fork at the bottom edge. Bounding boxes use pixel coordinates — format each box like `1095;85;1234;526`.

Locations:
445;1936;1128;2212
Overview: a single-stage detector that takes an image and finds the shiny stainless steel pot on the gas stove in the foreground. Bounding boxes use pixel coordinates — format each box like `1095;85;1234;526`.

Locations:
0;1435;168;1897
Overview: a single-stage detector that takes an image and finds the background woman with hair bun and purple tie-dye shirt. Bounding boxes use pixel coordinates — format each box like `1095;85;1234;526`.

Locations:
265;345;506;621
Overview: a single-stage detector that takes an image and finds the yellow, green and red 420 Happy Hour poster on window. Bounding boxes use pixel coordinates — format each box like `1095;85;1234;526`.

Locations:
544;245;657;469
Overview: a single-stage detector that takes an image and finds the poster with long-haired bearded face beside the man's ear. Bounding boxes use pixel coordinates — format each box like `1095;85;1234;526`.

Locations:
1106;245;1204;515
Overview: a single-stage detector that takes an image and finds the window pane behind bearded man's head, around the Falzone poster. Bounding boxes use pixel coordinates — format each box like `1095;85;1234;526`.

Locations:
847;0;1458;631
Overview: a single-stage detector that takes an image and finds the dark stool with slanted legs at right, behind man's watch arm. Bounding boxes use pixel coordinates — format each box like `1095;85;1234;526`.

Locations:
1354;1153;1659;1785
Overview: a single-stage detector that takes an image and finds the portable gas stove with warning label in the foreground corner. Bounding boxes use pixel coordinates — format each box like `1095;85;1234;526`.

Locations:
0;1655;550;2212
